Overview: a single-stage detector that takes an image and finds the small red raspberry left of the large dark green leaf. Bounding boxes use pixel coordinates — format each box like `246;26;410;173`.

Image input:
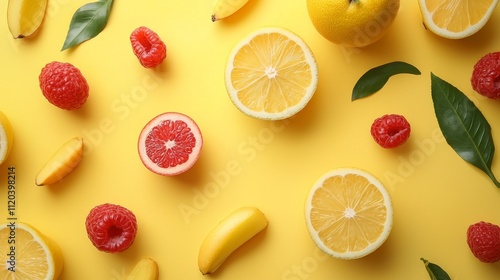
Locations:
370;114;411;149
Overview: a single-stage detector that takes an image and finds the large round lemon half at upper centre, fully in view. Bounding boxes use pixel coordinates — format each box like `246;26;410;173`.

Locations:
225;27;318;120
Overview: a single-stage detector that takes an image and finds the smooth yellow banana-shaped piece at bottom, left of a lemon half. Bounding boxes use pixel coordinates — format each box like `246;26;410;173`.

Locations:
198;207;268;275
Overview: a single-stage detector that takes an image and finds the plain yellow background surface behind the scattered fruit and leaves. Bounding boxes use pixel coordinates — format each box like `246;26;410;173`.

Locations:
0;0;500;280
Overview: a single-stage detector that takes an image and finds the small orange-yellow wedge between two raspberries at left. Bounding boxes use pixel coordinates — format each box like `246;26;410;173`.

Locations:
35;137;83;186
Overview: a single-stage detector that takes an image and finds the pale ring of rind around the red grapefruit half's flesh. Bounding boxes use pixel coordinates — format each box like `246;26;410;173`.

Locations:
138;112;203;176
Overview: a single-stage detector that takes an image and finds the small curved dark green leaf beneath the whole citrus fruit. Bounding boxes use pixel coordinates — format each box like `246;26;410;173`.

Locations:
351;61;420;101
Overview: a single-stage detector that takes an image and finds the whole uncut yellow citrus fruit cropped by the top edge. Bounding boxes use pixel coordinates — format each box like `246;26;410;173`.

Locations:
306;0;399;47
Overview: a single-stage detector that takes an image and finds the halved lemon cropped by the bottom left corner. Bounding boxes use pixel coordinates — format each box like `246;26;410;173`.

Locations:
0;222;63;280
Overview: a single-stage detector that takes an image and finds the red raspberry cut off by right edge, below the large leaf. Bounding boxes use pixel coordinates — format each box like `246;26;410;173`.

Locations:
467;221;500;263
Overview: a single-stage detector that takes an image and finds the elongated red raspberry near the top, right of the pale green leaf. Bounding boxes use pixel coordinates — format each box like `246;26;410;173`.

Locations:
130;26;167;68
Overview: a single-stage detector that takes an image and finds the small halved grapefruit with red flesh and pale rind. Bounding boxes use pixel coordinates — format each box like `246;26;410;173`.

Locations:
138;112;203;176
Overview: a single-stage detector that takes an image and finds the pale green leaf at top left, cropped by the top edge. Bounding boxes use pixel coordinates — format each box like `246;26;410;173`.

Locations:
61;0;113;51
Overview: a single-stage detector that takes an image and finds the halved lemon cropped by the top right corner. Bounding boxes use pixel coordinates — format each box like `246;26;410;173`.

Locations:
418;0;498;39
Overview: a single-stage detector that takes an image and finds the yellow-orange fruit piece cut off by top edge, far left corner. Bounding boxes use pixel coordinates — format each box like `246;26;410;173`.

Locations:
7;0;48;39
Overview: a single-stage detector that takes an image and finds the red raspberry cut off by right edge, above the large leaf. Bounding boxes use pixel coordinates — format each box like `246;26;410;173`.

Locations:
471;52;500;99
